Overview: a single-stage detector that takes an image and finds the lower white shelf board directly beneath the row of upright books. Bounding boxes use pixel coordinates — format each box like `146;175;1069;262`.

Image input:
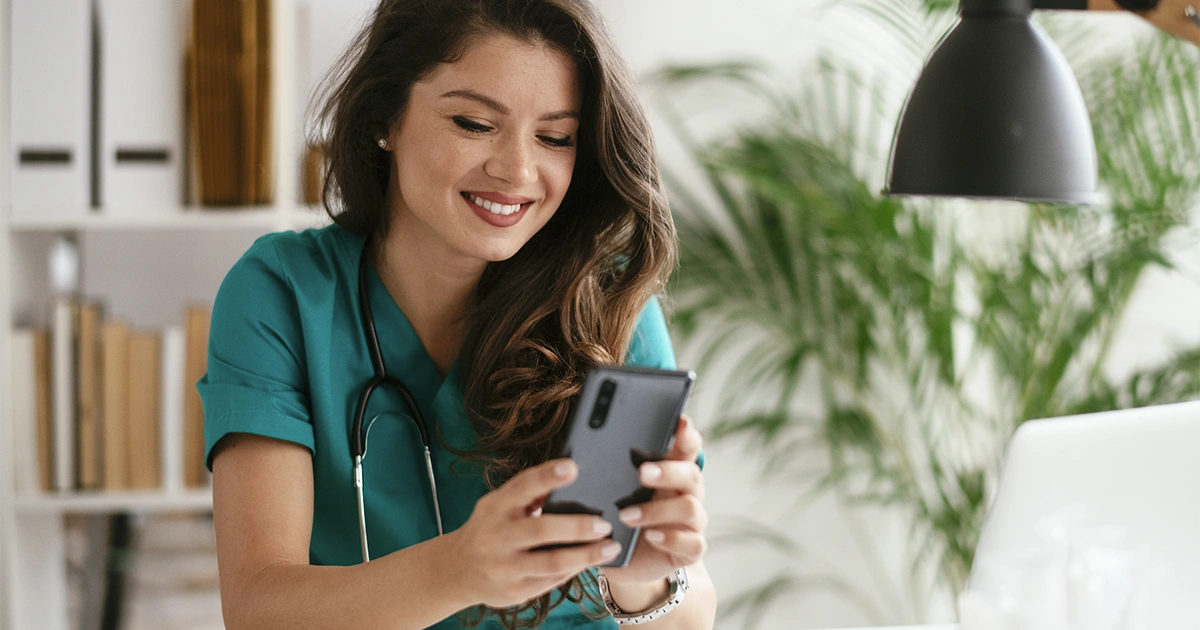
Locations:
13;488;212;515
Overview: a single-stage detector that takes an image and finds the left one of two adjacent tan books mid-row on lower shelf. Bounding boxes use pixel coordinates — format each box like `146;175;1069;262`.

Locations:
101;322;130;490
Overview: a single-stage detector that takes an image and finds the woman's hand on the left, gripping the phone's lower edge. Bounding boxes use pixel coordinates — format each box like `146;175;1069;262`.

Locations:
446;460;620;608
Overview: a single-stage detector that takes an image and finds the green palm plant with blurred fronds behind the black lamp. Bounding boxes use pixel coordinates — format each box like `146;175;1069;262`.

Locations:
653;0;1200;628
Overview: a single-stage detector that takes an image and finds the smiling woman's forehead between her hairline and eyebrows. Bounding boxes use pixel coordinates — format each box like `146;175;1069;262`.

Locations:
413;35;581;114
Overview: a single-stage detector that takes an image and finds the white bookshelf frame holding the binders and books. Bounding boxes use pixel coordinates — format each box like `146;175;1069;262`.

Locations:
0;0;344;630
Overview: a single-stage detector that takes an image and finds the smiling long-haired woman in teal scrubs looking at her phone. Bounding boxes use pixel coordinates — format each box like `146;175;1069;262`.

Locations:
198;0;715;630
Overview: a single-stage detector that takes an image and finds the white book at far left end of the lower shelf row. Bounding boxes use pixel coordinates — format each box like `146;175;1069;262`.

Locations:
10;329;42;496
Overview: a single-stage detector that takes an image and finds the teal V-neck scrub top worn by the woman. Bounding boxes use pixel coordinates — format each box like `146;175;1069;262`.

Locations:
197;224;696;630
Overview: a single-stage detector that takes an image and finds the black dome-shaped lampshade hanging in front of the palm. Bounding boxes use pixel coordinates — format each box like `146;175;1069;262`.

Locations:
887;0;1098;204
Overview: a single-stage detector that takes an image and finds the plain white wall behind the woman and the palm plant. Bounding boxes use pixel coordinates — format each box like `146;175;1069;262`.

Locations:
596;0;1200;630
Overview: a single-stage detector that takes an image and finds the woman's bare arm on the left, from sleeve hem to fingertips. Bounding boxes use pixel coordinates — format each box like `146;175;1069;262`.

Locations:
212;433;620;630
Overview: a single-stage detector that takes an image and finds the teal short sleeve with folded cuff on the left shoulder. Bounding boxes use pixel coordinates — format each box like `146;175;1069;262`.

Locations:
197;236;314;470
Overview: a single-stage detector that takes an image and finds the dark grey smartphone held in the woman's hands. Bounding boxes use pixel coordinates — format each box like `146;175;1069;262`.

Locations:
542;366;696;566
